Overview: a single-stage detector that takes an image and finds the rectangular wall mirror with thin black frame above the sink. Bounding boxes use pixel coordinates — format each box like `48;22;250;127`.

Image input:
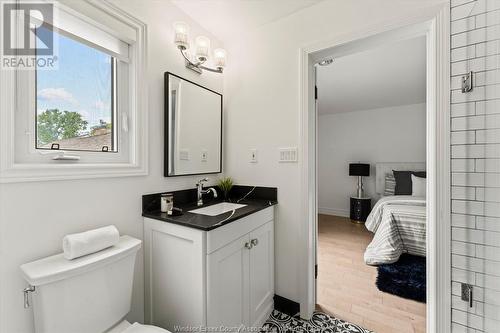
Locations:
165;72;222;177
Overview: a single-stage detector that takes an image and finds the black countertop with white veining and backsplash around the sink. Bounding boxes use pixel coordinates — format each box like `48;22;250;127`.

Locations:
142;185;278;231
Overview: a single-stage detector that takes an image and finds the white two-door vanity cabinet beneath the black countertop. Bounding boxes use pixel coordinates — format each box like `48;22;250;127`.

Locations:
144;207;274;331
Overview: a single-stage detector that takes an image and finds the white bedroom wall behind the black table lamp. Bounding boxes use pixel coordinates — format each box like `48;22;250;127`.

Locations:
318;103;426;216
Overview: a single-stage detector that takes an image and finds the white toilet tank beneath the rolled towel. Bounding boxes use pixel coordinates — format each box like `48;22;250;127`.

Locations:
21;236;141;333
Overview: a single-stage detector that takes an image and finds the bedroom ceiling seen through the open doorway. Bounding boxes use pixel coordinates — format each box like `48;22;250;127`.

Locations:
317;37;426;114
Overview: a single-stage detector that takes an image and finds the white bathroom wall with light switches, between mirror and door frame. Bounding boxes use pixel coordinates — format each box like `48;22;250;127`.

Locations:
224;0;446;301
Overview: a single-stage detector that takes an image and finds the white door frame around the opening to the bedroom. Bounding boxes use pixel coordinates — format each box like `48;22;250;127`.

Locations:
299;3;451;333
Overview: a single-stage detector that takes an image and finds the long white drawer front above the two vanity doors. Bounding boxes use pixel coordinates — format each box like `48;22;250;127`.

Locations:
207;207;274;254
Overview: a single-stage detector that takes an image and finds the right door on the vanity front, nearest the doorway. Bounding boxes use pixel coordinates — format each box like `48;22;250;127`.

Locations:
249;221;274;326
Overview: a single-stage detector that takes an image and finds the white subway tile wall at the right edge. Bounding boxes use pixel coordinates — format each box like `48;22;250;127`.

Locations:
450;0;500;333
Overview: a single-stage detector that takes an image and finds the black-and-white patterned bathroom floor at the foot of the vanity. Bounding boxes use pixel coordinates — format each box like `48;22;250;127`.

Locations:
261;310;374;333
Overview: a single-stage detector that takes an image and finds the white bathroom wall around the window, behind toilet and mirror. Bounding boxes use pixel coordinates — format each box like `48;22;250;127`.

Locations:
0;0;223;333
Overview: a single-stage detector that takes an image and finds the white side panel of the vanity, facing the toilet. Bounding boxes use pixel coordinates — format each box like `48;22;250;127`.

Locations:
144;218;207;332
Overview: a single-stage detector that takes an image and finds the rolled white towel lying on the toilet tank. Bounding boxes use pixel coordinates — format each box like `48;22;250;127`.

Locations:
63;225;120;260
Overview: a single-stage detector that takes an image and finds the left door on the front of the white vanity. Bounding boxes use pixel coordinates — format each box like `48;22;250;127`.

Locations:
207;234;251;327
